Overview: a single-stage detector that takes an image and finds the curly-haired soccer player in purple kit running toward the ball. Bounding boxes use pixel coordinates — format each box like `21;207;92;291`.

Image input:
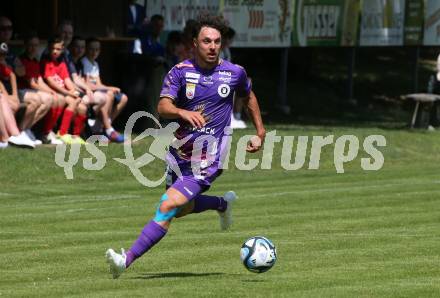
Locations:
106;15;266;278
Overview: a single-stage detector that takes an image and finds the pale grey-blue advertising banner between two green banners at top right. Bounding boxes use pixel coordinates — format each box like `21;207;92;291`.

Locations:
359;0;405;46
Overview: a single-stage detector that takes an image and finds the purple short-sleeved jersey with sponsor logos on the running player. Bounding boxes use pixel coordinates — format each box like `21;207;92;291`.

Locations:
160;60;251;170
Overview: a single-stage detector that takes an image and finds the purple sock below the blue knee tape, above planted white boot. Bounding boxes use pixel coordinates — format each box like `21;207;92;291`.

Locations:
125;220;167;268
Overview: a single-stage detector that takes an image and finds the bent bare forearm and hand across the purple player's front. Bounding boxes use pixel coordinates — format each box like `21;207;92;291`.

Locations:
157;97;205;128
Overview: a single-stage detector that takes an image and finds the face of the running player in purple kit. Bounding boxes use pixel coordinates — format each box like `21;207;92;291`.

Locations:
194;27;222;66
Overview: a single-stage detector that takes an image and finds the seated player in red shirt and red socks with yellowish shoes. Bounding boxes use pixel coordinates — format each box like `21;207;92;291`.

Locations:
41;36;90;144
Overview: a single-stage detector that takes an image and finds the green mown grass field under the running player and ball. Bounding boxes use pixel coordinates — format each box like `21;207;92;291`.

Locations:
0;126;440;297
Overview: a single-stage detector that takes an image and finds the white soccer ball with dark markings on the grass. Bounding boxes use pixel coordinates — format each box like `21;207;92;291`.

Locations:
240;236;277;273
